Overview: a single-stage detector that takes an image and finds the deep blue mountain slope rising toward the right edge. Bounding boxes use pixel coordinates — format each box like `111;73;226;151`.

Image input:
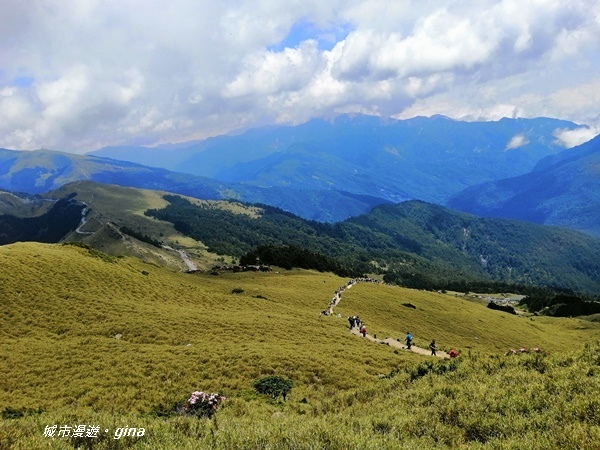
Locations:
448;137;600;236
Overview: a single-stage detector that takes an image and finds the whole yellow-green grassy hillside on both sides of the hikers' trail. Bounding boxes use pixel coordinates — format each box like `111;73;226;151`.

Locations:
0;243;600;449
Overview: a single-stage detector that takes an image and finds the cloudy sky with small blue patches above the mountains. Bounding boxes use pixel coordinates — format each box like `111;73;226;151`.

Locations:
0;0;600;153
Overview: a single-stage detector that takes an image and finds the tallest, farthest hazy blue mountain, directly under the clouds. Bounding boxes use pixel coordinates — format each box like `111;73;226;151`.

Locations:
91;115;577;203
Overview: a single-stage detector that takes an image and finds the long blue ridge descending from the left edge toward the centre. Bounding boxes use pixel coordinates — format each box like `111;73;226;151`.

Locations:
0;149;387;221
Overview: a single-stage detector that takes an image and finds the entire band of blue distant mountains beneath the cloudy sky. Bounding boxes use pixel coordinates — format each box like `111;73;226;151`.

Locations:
0;115;599;234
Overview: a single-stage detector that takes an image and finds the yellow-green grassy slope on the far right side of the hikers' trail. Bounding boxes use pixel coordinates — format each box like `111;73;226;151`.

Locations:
337;284;600;353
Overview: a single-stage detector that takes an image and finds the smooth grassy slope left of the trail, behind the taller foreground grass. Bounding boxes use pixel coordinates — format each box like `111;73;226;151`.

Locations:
0;244;410;410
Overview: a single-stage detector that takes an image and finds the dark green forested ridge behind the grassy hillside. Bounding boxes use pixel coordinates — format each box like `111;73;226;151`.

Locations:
146;195;600;304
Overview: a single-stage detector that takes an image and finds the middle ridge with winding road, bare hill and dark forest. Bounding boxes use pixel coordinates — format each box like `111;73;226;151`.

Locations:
0;181;600;294
